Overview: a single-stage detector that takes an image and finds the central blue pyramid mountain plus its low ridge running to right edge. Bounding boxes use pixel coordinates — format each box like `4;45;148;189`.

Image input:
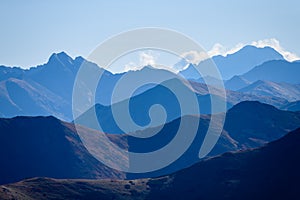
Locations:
75;79;290;133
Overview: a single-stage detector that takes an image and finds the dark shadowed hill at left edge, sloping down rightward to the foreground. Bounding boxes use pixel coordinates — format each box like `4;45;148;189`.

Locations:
0;117;126;184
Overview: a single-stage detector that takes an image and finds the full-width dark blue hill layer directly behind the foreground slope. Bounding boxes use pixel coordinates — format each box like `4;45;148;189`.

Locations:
0;102;300;184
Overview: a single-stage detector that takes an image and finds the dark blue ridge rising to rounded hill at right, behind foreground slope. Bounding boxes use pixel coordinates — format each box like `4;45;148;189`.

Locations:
127;102;300;178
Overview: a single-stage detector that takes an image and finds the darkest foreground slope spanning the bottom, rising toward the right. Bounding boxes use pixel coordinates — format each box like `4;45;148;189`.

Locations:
0;129;300;200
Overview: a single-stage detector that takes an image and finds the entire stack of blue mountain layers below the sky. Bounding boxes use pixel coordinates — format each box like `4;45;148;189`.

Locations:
0;46;300;199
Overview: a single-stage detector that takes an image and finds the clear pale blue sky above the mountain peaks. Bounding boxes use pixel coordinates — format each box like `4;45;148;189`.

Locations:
0;0;300;68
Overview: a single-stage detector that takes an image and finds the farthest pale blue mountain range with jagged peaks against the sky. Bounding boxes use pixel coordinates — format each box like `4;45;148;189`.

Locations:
0;46;300;121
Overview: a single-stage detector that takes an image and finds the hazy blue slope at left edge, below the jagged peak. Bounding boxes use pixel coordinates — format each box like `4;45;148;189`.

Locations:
0;78;70;118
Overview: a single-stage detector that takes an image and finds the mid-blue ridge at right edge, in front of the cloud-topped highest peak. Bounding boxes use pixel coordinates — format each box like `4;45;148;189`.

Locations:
225;60;300;97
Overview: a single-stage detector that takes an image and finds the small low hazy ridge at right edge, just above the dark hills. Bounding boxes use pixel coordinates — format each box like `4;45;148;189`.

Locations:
239;80;300;101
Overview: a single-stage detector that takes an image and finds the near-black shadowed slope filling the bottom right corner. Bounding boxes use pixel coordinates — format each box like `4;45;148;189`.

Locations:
148;126;300;200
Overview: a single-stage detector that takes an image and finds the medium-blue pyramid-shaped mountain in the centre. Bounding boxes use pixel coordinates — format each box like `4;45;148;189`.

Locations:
75;79;233;133
